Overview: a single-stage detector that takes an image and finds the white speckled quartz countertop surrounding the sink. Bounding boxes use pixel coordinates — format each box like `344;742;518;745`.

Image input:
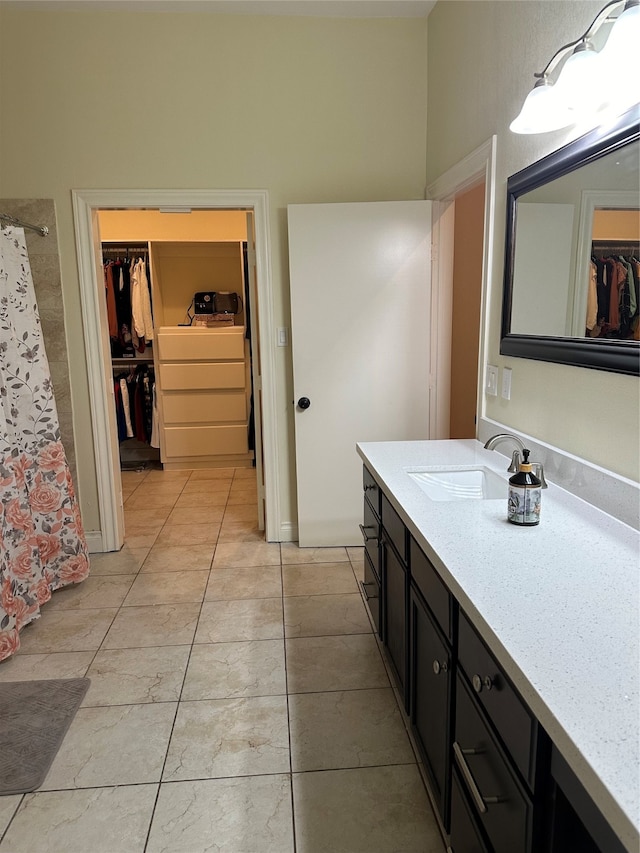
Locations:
357;439;640;853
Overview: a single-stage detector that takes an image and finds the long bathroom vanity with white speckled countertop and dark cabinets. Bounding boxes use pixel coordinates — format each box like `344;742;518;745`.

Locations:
358;440;640;853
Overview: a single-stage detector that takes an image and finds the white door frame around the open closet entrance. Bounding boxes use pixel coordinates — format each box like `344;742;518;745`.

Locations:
71;189;281;551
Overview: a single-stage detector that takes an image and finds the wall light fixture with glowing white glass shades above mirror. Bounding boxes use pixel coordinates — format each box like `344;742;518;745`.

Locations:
509;0;640;133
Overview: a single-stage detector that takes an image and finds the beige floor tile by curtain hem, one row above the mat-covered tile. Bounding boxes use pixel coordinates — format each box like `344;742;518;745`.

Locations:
15;604;118;654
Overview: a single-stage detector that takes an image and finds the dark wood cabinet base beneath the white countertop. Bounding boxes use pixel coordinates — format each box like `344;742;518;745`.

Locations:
362;468;625;853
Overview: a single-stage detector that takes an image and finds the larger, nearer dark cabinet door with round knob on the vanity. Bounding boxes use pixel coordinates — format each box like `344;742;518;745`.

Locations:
409;584;453;830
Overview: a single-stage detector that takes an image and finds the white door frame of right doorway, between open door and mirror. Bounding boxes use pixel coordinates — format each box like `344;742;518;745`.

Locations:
426;135;497;439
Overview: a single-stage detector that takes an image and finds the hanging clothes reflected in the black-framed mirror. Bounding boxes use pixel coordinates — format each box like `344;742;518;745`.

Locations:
586;241;640;340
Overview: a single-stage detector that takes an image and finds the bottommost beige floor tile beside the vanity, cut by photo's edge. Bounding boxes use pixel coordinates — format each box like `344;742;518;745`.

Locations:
293;764;445;853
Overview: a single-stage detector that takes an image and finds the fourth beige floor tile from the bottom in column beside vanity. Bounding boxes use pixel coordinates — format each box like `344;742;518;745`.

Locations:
284;593;371;637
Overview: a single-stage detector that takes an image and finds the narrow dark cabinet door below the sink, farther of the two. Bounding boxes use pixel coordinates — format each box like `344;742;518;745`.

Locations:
382;540;408;708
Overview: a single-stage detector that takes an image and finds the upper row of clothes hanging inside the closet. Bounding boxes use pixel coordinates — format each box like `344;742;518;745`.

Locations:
102;243;153;358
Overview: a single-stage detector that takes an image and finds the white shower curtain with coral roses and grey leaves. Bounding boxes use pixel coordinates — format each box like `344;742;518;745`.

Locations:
0;227;89;661
